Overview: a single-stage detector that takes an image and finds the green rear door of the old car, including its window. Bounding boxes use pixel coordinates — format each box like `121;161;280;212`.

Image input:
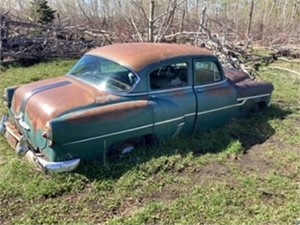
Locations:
148;60;196;139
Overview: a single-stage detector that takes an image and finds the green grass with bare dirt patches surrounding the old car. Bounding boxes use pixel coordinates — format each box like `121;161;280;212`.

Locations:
0;58;300;224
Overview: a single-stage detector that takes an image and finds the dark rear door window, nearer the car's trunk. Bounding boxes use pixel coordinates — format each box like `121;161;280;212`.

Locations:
150;62;188;90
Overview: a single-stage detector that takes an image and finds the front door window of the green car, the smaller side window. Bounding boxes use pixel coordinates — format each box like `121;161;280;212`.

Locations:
194;61;222;85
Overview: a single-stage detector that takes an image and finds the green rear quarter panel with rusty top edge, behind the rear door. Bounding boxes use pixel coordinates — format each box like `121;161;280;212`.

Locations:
45;100;153;161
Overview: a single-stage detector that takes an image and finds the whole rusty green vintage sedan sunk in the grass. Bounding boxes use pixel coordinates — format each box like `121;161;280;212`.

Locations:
0;43;273;172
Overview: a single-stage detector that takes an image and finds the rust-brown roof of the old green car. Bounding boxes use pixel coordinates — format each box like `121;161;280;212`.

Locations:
86;43;213;72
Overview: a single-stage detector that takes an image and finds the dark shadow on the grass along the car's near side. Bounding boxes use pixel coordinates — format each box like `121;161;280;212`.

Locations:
76;105;292;180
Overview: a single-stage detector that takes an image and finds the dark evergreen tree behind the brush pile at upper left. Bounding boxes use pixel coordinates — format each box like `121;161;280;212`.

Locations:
30;0;56;25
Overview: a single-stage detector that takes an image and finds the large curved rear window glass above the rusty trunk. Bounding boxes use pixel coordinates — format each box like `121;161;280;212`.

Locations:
68;55;138;92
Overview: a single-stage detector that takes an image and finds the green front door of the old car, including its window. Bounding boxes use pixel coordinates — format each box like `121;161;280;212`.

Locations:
193;57;238;131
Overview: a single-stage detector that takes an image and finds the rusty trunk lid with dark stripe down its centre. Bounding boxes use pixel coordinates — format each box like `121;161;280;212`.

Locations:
12;77;101;131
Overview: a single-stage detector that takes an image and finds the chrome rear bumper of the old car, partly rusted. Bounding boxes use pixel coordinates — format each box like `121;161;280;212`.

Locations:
0;115;80;172
